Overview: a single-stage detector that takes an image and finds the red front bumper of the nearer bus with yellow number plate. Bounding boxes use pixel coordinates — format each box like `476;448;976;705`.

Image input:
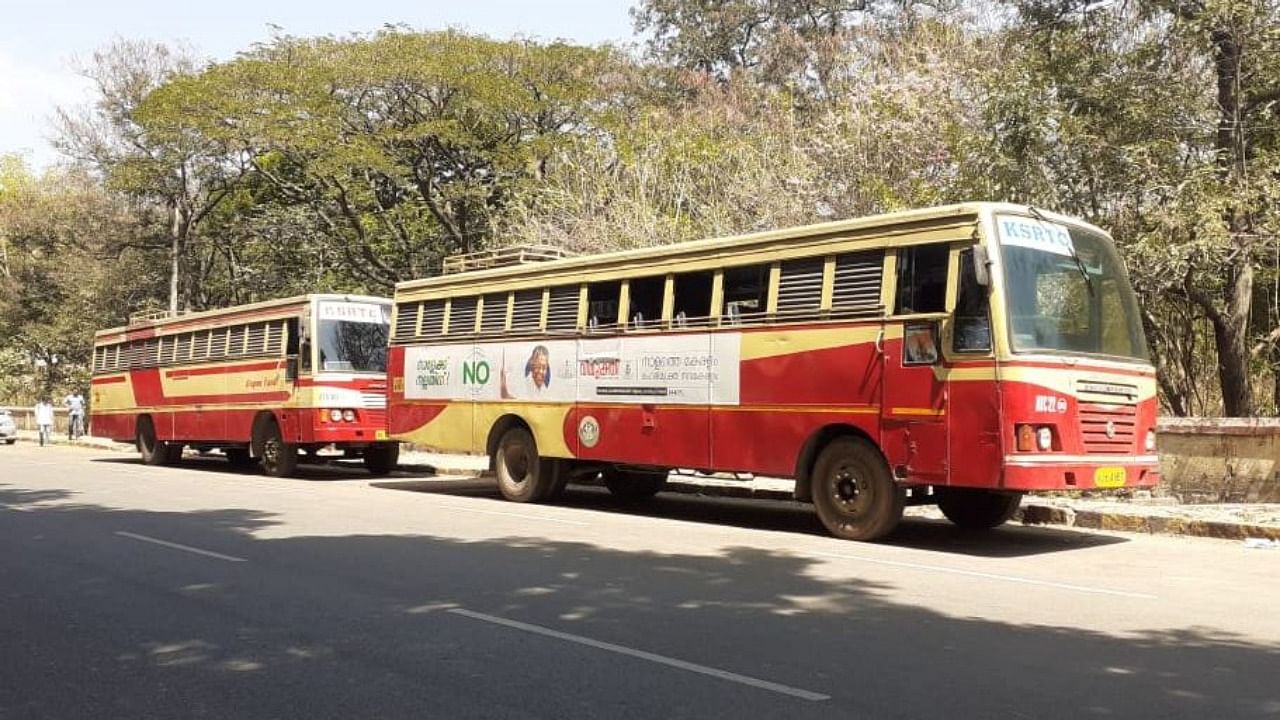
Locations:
1001;455;1160;491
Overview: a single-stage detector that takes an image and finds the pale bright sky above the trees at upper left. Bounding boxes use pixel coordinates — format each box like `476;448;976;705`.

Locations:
0;0;635;169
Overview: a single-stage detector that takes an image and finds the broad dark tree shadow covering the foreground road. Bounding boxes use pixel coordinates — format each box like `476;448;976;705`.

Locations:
0;491;1280;720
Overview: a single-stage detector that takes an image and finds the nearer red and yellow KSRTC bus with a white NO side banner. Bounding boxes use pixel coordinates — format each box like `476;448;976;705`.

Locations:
388;204;1160;539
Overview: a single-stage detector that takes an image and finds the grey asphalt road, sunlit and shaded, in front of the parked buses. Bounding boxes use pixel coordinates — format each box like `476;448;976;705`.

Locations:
0;445;1280;720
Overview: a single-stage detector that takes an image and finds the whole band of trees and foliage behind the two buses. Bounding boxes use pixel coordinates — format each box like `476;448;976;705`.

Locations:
0;9;1280;414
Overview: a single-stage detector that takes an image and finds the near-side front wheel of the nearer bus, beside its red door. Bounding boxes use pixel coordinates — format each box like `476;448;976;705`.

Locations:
810;437;906;541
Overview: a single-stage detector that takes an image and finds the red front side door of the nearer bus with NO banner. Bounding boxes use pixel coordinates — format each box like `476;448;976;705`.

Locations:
881;319;948;484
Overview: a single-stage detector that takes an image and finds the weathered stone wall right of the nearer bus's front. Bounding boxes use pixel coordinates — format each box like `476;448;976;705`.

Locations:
1157;418;1280;502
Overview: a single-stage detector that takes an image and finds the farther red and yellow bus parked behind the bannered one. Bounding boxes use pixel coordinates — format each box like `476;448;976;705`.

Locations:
91;295;399;477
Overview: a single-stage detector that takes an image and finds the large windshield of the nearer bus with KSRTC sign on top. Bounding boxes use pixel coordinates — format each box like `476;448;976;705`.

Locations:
996;215;1149;361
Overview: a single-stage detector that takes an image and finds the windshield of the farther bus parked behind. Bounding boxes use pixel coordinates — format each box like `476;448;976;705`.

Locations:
315;302;390;373
